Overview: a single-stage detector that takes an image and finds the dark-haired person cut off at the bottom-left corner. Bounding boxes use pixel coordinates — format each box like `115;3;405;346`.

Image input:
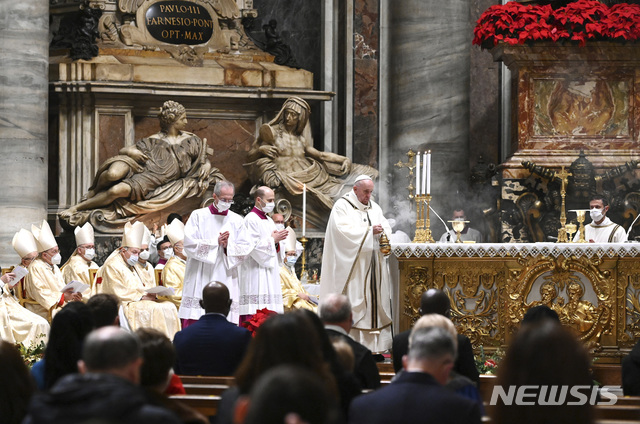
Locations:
0;340;36;424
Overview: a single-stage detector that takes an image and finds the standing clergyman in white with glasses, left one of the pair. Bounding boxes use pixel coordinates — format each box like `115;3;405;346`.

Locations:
179;181;243;326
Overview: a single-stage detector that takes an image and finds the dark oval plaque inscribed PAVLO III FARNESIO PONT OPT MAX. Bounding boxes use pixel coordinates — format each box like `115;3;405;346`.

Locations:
145;1;213;45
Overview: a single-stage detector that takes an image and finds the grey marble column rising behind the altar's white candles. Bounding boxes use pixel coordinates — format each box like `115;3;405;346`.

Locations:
380;0;472;239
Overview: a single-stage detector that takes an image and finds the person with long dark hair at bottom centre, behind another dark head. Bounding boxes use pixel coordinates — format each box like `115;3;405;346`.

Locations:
217;313;338;424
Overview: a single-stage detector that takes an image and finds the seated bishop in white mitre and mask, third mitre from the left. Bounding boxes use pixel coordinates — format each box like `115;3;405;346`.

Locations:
62;222;98;301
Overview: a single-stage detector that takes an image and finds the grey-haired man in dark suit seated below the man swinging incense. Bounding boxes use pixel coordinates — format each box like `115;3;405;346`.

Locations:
319;293;380;389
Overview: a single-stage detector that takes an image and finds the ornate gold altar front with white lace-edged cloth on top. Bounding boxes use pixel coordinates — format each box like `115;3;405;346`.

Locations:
392;243;640;362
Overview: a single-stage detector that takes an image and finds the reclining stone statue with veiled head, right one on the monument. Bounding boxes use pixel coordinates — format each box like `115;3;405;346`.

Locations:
245;97;378;228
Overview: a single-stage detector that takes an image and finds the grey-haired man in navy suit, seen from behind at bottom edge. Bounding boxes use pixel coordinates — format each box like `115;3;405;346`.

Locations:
349;327;480;424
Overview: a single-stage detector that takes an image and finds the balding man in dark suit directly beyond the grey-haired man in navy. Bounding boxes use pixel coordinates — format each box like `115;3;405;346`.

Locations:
393;289;480;384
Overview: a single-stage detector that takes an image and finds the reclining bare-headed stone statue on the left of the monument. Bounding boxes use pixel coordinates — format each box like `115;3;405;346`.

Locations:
60;100;223;233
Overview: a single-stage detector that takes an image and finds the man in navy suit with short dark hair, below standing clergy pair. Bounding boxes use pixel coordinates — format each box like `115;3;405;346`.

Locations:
173;282;251;376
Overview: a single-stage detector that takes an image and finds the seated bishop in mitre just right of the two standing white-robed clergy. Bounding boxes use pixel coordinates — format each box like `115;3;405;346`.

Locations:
280;227;318;312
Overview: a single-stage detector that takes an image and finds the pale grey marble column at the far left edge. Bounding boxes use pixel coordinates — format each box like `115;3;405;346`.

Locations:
0;0;49;267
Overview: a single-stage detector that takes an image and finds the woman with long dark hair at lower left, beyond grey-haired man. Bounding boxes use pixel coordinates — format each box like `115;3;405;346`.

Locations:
31;302;94;390
